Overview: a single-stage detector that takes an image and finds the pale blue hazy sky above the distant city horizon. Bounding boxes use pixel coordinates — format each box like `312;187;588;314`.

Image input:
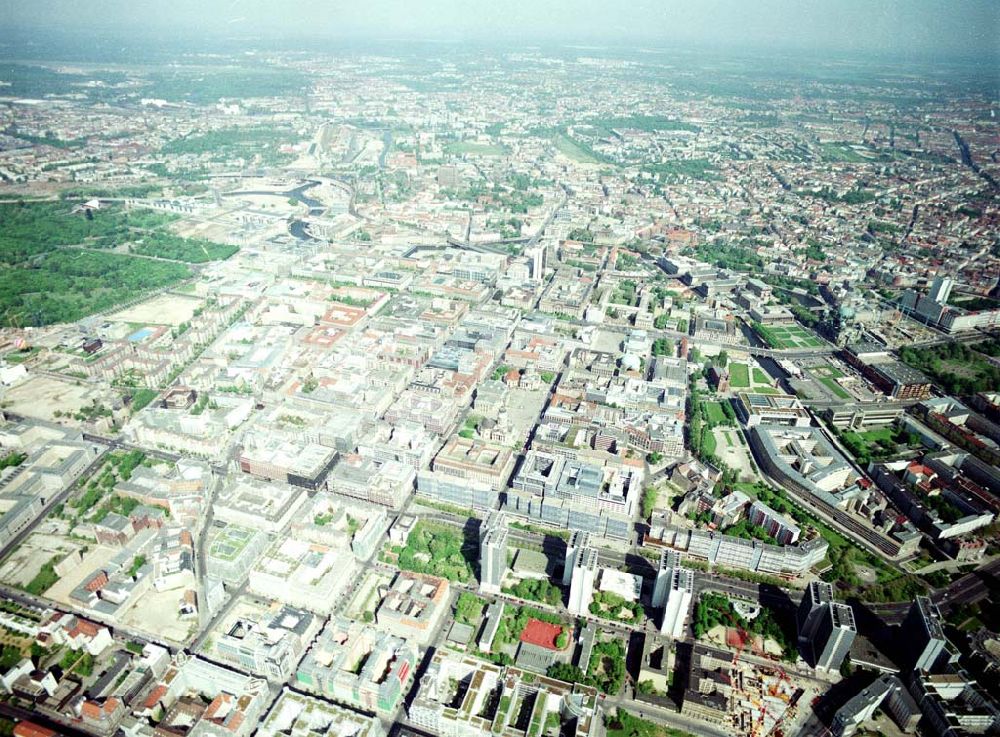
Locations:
0;0;1000;57
